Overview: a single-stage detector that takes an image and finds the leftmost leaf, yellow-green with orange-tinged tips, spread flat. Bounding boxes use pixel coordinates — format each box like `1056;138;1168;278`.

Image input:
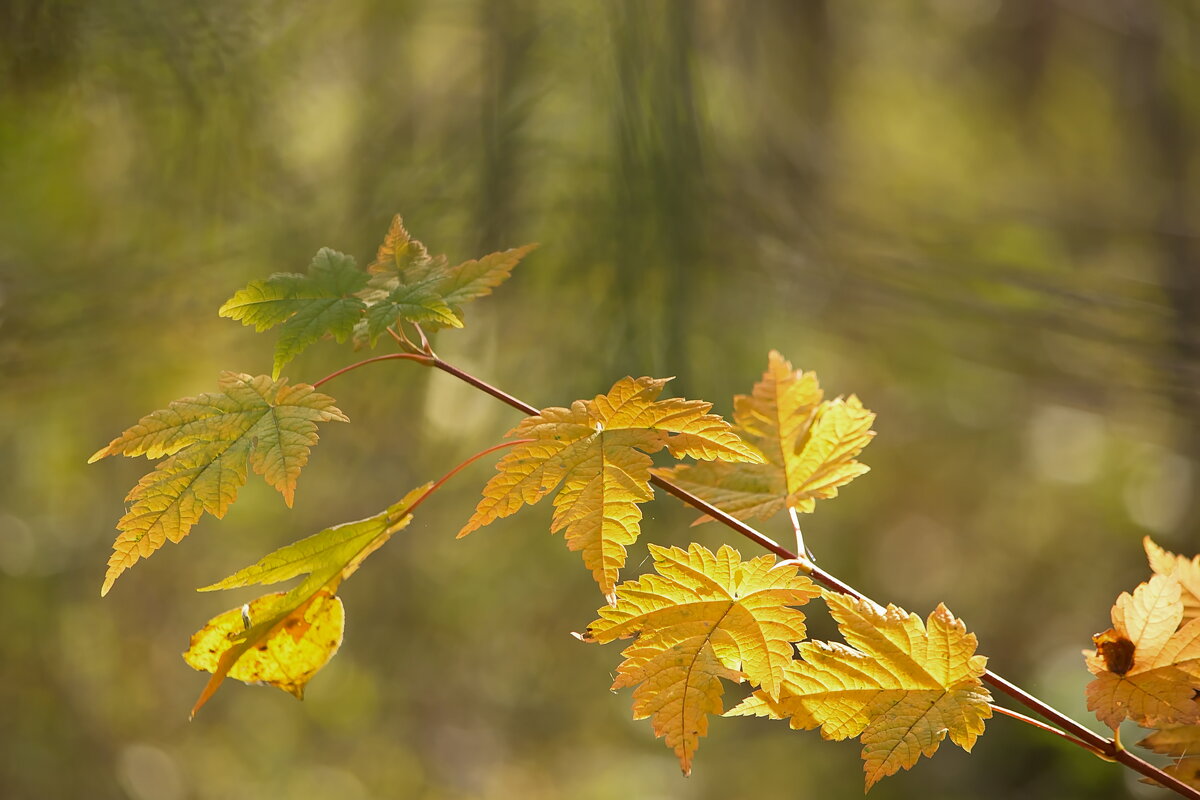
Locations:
88;372;348;595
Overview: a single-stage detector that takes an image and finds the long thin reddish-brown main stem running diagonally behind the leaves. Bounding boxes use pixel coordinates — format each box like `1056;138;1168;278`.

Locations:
357;354;1200;800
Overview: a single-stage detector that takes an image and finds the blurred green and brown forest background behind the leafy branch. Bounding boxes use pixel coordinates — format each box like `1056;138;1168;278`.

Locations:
0;0;1200;800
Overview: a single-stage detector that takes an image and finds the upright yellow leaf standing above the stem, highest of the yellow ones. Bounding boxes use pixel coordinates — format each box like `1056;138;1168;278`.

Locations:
655;350;875;523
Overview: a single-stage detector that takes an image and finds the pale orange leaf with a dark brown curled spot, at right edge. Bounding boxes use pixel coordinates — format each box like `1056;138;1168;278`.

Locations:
1084;575;1200;730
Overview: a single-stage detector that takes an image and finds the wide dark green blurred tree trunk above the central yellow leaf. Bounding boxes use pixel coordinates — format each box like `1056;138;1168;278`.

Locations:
604;0;706;393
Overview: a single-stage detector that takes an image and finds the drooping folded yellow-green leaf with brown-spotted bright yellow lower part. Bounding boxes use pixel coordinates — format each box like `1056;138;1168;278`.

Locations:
184;483;432;715
